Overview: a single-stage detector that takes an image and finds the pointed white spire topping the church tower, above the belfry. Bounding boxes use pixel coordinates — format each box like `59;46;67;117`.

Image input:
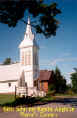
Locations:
19;18;38;48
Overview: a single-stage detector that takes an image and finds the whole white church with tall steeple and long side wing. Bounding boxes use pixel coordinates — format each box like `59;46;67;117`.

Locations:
0;18;44;96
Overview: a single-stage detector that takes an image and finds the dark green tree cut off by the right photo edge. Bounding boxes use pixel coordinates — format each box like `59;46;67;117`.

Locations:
71;68;77;93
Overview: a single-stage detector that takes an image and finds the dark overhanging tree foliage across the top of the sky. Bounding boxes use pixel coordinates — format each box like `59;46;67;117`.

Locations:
0;0;61;37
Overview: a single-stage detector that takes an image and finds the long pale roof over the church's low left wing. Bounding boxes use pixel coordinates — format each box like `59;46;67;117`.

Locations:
0;63;21;82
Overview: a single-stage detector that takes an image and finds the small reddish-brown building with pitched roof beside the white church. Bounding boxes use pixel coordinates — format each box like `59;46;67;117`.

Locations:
35;70;54;92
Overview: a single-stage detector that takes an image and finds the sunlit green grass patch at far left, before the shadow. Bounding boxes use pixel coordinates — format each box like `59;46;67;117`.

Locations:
0;94;15;105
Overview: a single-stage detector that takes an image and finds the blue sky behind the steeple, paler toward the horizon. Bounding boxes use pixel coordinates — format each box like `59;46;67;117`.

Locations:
0;0;77;82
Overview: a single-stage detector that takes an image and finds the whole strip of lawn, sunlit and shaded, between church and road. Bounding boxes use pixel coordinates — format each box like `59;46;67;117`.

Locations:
0;94;77;106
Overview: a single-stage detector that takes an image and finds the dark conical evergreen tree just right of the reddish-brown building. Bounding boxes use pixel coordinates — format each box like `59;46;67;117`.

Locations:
54;67;66;93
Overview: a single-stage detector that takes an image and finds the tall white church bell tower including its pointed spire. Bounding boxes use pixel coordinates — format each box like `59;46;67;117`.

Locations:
19;18;39;87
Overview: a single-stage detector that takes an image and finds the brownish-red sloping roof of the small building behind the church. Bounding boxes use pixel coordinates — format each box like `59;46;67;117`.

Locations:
39;70;53;81
